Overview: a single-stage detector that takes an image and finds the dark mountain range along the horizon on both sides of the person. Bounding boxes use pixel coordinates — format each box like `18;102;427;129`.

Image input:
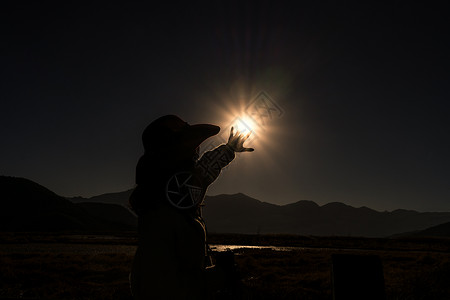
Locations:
0;176;450;237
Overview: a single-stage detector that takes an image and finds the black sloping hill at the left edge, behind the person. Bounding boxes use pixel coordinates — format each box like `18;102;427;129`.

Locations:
0;176;136;231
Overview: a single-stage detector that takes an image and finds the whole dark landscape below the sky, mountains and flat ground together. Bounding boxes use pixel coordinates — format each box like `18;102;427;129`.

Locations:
0;176;450;299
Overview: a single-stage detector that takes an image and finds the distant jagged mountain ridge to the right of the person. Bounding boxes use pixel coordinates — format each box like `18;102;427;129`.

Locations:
203;194;450;237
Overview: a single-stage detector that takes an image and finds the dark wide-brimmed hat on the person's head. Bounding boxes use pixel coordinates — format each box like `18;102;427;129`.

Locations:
142;115;220;152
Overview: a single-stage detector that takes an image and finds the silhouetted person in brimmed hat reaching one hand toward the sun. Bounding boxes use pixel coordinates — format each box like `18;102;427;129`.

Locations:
130;115;253;299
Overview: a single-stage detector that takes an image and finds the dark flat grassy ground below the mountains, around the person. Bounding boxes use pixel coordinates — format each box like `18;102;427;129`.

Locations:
0;233;450;299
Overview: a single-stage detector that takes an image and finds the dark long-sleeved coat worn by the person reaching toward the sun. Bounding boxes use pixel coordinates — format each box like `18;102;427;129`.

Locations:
130;145;234;300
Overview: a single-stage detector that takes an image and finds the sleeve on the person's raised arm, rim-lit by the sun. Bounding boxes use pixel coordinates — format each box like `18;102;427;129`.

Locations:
195;144;235;187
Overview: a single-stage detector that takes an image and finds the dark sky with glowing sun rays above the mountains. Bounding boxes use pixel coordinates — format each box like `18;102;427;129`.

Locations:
0;1;450;211
